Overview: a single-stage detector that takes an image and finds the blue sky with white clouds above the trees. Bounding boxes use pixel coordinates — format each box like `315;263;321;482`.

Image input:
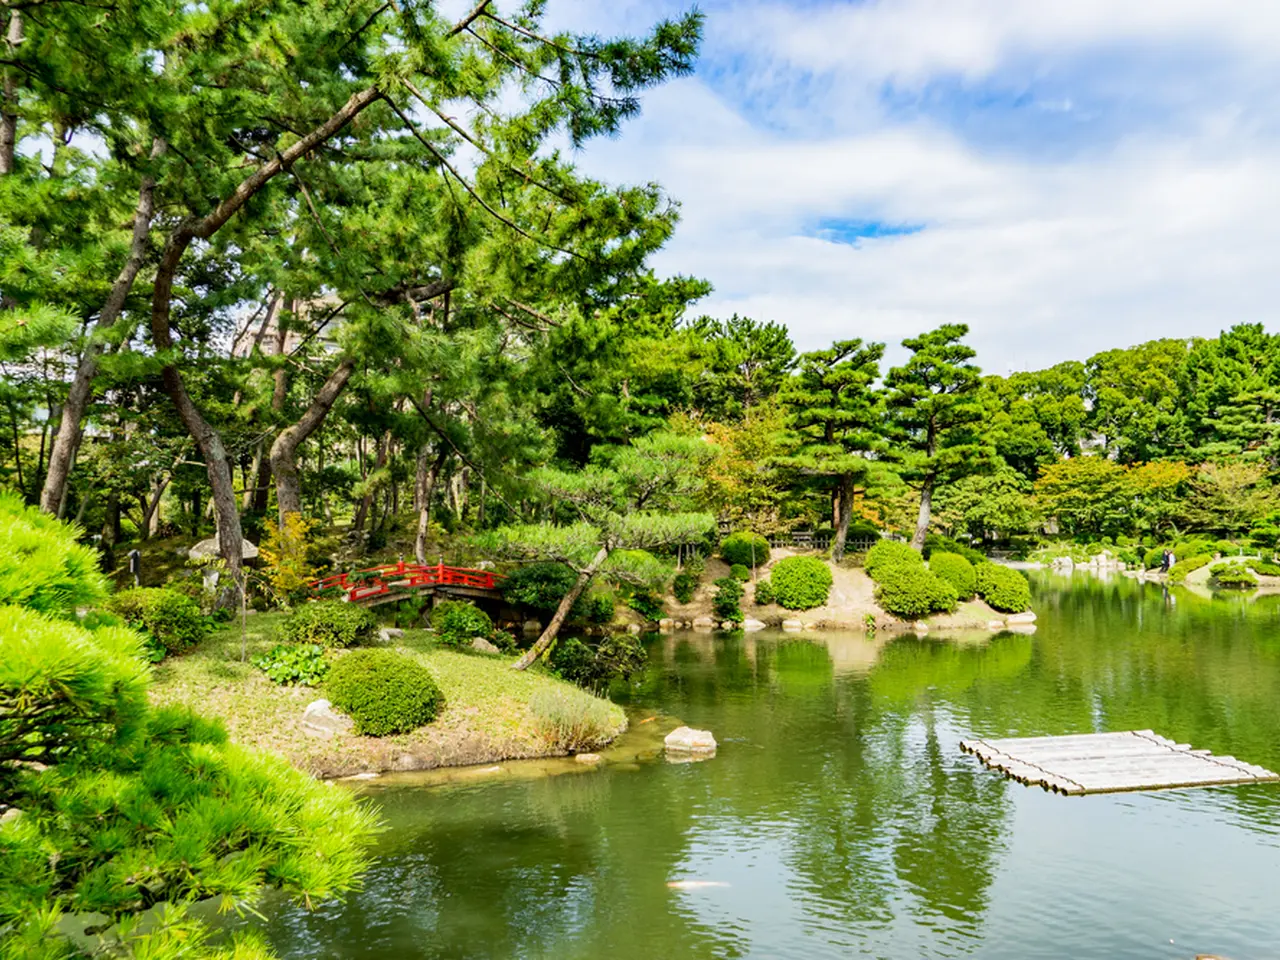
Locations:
535;0;1280;374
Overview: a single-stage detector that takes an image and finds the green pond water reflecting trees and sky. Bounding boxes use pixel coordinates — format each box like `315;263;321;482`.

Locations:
252;575;1280;960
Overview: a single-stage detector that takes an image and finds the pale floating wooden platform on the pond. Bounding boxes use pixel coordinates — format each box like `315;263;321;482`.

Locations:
960;730;1280;795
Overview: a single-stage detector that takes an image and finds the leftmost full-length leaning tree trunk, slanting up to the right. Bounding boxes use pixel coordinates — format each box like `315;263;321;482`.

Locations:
40;172;157;513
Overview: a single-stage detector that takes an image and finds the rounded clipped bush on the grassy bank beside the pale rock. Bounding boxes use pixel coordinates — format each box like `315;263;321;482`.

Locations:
325;649;444;737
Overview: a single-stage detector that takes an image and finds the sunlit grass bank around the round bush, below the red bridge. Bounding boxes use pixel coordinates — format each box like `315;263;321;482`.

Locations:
151;613;626;777
